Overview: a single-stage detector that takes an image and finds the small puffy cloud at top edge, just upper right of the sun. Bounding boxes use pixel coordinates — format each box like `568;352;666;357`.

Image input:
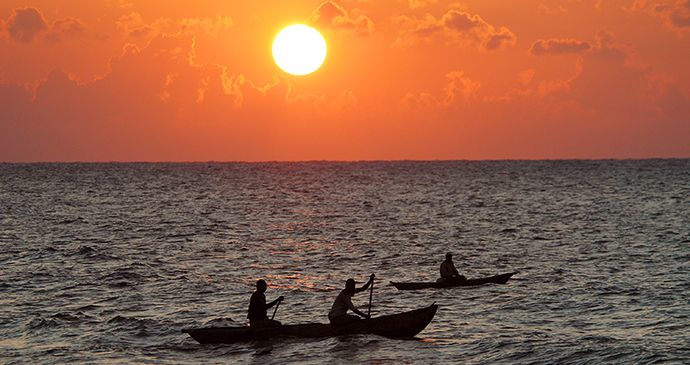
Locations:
308;1;374;35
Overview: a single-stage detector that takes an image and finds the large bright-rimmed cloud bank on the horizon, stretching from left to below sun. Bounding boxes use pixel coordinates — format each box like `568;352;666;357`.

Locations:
0;33;368;161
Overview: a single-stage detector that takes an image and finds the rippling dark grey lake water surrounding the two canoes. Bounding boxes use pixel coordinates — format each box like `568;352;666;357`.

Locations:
0;159;690;364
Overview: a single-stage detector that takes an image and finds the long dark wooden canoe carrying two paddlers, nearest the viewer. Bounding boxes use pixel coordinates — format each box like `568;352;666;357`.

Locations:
182;303;438;343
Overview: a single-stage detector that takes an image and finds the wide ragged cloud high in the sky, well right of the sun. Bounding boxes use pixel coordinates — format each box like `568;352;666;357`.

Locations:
393;10;517;51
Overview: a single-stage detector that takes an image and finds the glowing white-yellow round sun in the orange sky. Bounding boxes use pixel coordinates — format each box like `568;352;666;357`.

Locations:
273;24;327;75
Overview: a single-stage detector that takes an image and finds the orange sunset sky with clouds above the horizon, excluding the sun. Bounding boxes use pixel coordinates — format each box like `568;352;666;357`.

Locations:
0;0;690;162
